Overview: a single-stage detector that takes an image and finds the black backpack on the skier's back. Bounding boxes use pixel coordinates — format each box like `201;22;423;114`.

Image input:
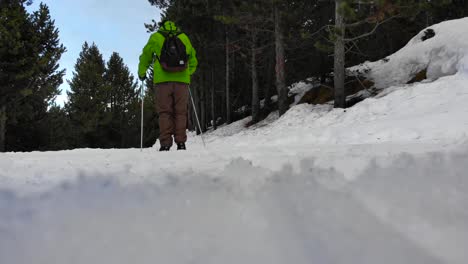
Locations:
159;32;188;72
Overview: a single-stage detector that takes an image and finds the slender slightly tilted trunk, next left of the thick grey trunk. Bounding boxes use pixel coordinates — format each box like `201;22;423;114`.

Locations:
275;6;289;116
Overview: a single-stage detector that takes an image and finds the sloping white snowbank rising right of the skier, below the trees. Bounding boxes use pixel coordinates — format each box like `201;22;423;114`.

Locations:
210;75;468;148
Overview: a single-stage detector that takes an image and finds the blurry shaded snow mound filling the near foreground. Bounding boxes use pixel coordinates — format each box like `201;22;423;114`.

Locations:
0;148;468;264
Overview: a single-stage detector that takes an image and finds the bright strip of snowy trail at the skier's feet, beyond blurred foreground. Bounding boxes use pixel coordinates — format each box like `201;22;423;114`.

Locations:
0;140;458;194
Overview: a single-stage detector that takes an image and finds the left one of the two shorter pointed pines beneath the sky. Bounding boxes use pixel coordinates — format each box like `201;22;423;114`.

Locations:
65;42;107;148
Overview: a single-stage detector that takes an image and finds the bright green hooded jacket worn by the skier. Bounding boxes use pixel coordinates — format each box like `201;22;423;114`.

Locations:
138;21;198;84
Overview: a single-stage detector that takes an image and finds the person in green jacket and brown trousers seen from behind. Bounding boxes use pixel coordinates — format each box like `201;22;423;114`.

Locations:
138;21;198;151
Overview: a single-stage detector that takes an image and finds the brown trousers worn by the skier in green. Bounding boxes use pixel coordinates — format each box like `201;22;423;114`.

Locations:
156;82;189;147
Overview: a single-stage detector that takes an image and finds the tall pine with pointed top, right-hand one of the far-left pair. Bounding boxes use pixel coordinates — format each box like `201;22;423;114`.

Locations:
9;4;65;151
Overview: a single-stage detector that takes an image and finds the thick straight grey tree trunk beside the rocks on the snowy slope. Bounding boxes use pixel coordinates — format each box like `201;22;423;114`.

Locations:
334;0;346;108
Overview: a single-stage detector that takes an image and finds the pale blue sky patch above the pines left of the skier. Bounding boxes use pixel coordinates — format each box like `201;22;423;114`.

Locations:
29;0;160;104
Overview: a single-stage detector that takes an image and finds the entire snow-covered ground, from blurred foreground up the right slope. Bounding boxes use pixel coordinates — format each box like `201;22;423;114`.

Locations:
0;20;468;264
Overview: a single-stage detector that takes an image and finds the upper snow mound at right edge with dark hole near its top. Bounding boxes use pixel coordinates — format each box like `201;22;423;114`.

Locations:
349;18;468;88
